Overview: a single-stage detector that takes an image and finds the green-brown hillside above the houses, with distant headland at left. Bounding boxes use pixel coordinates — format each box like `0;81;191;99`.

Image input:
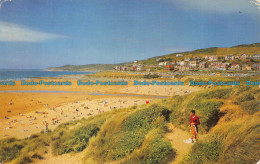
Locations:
46;43;260;71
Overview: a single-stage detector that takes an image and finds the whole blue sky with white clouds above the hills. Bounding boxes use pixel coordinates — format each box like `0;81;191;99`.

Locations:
0;0;260;69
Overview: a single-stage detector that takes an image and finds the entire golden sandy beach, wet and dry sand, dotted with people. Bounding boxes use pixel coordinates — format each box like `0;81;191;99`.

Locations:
0;79;199;139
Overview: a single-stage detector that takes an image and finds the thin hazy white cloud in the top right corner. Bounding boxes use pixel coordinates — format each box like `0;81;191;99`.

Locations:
165;0;260;13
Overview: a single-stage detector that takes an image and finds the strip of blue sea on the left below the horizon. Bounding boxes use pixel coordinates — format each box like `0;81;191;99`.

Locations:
0;69;94;81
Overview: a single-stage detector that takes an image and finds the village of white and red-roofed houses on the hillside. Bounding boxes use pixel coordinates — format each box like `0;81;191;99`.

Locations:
114;54;260;72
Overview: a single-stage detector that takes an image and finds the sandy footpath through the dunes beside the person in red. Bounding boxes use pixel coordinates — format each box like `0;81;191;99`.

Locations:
165;123;192;164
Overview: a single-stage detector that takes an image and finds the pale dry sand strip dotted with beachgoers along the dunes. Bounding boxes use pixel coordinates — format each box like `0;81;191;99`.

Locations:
0;97;151;139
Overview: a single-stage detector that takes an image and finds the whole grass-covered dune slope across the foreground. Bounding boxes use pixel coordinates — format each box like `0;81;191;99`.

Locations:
0;77;260;163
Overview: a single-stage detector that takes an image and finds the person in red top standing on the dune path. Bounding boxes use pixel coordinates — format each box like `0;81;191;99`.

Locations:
189;110;200;142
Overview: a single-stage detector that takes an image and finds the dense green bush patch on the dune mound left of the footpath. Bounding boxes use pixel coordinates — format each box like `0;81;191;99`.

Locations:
107;105;169;160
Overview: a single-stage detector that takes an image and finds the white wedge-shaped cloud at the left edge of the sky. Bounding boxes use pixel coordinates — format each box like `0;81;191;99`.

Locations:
0;21;65;42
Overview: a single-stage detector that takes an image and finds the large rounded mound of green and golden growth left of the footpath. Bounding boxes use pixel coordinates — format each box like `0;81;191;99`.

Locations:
85;105;173;163
